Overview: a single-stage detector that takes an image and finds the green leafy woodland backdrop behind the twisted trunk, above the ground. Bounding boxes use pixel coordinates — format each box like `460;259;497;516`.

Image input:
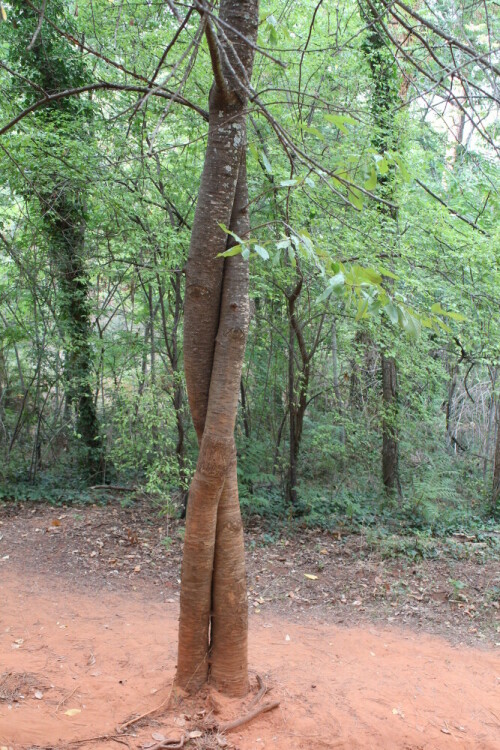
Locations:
0;0;500;540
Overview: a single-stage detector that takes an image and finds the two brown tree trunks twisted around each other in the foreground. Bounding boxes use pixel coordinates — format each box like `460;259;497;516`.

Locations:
177;0;258;695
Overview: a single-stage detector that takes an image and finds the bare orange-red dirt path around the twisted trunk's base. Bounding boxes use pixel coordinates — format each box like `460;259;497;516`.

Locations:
0;502;500;750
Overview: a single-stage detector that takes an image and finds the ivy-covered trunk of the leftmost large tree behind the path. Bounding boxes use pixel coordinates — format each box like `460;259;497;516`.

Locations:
14;0;104;481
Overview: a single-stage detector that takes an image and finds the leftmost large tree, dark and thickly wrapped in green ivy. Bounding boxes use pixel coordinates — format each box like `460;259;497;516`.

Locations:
7;0;104;479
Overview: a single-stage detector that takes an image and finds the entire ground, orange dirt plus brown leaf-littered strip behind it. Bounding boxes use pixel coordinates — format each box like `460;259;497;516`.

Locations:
0;504;500;750
